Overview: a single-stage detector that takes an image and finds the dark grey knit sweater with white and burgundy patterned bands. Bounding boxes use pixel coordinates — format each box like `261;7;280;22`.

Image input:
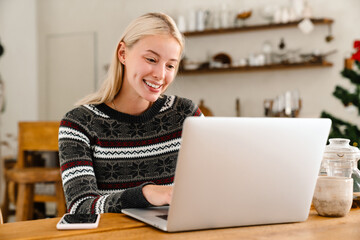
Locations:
59;95;202;213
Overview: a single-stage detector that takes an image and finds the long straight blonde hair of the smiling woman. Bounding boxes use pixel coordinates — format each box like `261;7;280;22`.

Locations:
75;13;185;106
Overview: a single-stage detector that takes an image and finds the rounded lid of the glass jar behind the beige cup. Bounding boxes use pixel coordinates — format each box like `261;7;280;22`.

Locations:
324;138;360;160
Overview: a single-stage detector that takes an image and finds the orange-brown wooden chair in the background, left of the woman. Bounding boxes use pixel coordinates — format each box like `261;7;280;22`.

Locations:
4;122;66;221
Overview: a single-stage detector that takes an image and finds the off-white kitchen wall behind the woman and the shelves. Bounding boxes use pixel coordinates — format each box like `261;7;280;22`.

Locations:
0;0;360;154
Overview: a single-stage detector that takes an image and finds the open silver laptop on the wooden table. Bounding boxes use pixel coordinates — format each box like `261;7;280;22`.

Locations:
122;117;331;232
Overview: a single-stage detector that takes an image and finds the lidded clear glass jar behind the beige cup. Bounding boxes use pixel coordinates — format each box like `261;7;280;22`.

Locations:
320;138;360;192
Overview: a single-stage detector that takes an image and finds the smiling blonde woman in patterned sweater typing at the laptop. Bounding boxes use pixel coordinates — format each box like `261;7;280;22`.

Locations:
59;13;202;213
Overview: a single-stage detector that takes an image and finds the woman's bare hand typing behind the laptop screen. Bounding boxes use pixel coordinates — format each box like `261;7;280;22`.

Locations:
142;184;173;206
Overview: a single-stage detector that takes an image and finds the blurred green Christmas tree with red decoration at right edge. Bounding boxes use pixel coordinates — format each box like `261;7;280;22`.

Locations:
321;41;360;147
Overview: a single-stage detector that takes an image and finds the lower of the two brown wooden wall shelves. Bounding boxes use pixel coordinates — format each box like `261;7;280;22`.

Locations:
179;61;333;75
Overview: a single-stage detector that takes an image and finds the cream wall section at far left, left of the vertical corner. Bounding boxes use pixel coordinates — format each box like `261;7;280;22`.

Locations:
0;0;39;201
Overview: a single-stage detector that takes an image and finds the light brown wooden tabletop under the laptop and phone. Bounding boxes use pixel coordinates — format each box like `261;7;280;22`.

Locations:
0;208;360;240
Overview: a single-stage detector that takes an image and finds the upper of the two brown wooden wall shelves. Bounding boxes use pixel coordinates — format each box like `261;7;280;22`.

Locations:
183;18;334;37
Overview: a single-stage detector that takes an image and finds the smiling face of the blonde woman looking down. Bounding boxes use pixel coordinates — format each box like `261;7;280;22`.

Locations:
118;35;181;102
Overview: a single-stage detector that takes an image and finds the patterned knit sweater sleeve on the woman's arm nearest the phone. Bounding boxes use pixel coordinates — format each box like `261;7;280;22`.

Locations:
59;114;151;214
